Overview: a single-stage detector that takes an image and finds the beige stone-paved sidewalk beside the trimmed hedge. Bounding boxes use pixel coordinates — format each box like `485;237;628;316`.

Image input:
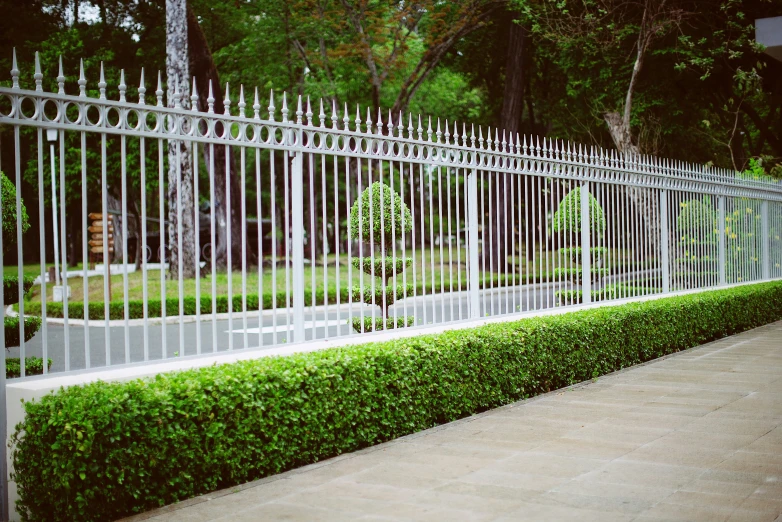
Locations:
134;322;782;522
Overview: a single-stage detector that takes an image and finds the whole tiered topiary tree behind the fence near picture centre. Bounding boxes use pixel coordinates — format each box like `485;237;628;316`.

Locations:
350;182;414;332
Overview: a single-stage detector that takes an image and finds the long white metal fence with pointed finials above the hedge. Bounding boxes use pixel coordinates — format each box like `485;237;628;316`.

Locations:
0;51;782;377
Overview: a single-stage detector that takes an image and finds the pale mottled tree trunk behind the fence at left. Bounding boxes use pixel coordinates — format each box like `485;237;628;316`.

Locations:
166;0;197;279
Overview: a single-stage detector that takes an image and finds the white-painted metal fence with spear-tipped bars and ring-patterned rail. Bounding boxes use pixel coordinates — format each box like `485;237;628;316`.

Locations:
0;51;782;378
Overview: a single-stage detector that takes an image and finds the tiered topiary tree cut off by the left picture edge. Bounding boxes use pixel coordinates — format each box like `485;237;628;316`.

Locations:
0;172;41;348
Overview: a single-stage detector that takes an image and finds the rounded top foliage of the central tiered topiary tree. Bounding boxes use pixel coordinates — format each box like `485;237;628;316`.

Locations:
350;181;413;248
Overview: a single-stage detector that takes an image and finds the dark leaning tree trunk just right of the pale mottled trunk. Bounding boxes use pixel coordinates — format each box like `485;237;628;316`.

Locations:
187;7;258;269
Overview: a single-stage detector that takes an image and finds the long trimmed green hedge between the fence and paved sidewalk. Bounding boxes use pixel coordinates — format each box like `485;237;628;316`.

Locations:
12;282;782;521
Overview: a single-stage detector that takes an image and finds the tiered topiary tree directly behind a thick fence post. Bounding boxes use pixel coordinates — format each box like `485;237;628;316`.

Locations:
551;187;608;304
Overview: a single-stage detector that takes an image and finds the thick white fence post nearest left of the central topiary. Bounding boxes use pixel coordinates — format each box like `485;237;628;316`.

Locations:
289;130;305;343
